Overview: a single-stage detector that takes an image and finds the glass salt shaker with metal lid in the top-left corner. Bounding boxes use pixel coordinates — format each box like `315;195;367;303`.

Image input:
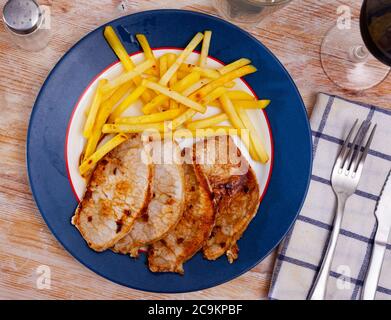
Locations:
3;0;50;51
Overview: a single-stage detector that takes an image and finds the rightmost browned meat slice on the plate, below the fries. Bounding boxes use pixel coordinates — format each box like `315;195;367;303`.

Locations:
193;136;259;263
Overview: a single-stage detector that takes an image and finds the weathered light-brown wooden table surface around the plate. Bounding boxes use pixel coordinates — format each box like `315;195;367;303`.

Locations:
0;0;391;299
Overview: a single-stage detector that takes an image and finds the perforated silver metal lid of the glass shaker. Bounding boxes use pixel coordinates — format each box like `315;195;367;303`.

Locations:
3;0;41;34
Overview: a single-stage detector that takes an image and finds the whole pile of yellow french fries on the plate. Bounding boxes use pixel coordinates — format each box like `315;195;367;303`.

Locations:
79;26;270;176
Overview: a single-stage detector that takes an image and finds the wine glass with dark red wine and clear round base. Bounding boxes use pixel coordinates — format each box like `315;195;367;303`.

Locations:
321;0;391;91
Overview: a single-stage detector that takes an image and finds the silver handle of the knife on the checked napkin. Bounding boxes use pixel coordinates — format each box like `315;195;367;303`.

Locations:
361;238;386;300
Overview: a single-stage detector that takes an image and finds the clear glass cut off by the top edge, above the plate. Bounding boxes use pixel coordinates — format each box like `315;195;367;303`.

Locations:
213;0;292;27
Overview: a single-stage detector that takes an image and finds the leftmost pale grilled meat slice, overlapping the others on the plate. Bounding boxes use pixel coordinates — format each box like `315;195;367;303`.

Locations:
72;135;153;251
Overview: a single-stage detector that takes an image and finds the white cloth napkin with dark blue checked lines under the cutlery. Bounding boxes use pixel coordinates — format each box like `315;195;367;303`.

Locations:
269;93;391;300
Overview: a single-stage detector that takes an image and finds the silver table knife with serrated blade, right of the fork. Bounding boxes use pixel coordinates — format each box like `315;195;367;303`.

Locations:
362;170;391;300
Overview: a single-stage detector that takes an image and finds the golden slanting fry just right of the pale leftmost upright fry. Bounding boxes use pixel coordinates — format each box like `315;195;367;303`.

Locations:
84;82;132;159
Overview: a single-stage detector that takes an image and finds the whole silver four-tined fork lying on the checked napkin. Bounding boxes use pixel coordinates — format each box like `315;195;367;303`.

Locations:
308;119;377;300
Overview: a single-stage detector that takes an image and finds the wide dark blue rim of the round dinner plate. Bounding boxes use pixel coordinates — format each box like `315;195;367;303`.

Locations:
27;10;312;292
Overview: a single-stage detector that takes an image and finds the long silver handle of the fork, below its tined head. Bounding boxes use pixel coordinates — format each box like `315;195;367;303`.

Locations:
309;195;347;300
